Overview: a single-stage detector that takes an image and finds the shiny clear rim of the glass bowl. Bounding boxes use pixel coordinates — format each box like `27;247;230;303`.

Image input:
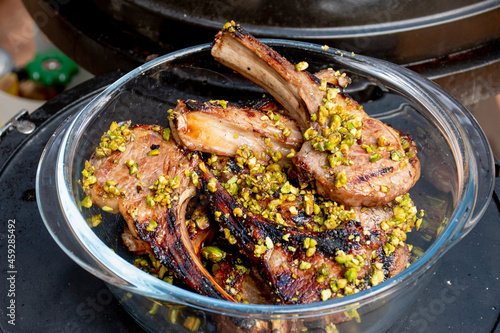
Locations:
37;39;494;318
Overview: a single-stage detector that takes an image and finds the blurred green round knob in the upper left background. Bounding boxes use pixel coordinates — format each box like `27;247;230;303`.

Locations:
25;49;78;87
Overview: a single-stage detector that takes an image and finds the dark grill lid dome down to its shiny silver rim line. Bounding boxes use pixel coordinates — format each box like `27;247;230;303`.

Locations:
94;0;500;39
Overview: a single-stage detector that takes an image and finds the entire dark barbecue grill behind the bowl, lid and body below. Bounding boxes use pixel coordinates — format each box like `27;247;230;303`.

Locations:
23;0;500;106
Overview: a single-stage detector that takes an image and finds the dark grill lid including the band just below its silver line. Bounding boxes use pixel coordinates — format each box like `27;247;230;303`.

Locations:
93;0;500;63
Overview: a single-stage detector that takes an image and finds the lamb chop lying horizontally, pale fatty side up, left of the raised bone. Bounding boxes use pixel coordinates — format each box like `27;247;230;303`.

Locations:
170;100;303;160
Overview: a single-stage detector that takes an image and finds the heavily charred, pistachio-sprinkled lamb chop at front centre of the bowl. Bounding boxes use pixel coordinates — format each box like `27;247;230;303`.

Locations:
195;162;385;304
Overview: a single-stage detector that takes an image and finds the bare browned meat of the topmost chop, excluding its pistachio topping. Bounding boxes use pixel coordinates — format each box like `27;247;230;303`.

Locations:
294;124;420;207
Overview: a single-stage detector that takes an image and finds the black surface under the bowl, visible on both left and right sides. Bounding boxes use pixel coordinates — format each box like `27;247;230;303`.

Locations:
0;72;500;333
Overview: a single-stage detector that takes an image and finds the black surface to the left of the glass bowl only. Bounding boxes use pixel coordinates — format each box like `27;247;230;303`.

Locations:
0;72;145;332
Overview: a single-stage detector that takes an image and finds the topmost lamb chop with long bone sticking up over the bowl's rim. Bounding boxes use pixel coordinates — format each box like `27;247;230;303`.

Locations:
212;23;420;206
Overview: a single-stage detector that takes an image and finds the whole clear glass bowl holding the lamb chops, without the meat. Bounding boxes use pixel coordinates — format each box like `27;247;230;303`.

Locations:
36;40;494;332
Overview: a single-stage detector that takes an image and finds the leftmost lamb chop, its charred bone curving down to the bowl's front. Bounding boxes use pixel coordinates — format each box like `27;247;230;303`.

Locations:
83;125;233;301
